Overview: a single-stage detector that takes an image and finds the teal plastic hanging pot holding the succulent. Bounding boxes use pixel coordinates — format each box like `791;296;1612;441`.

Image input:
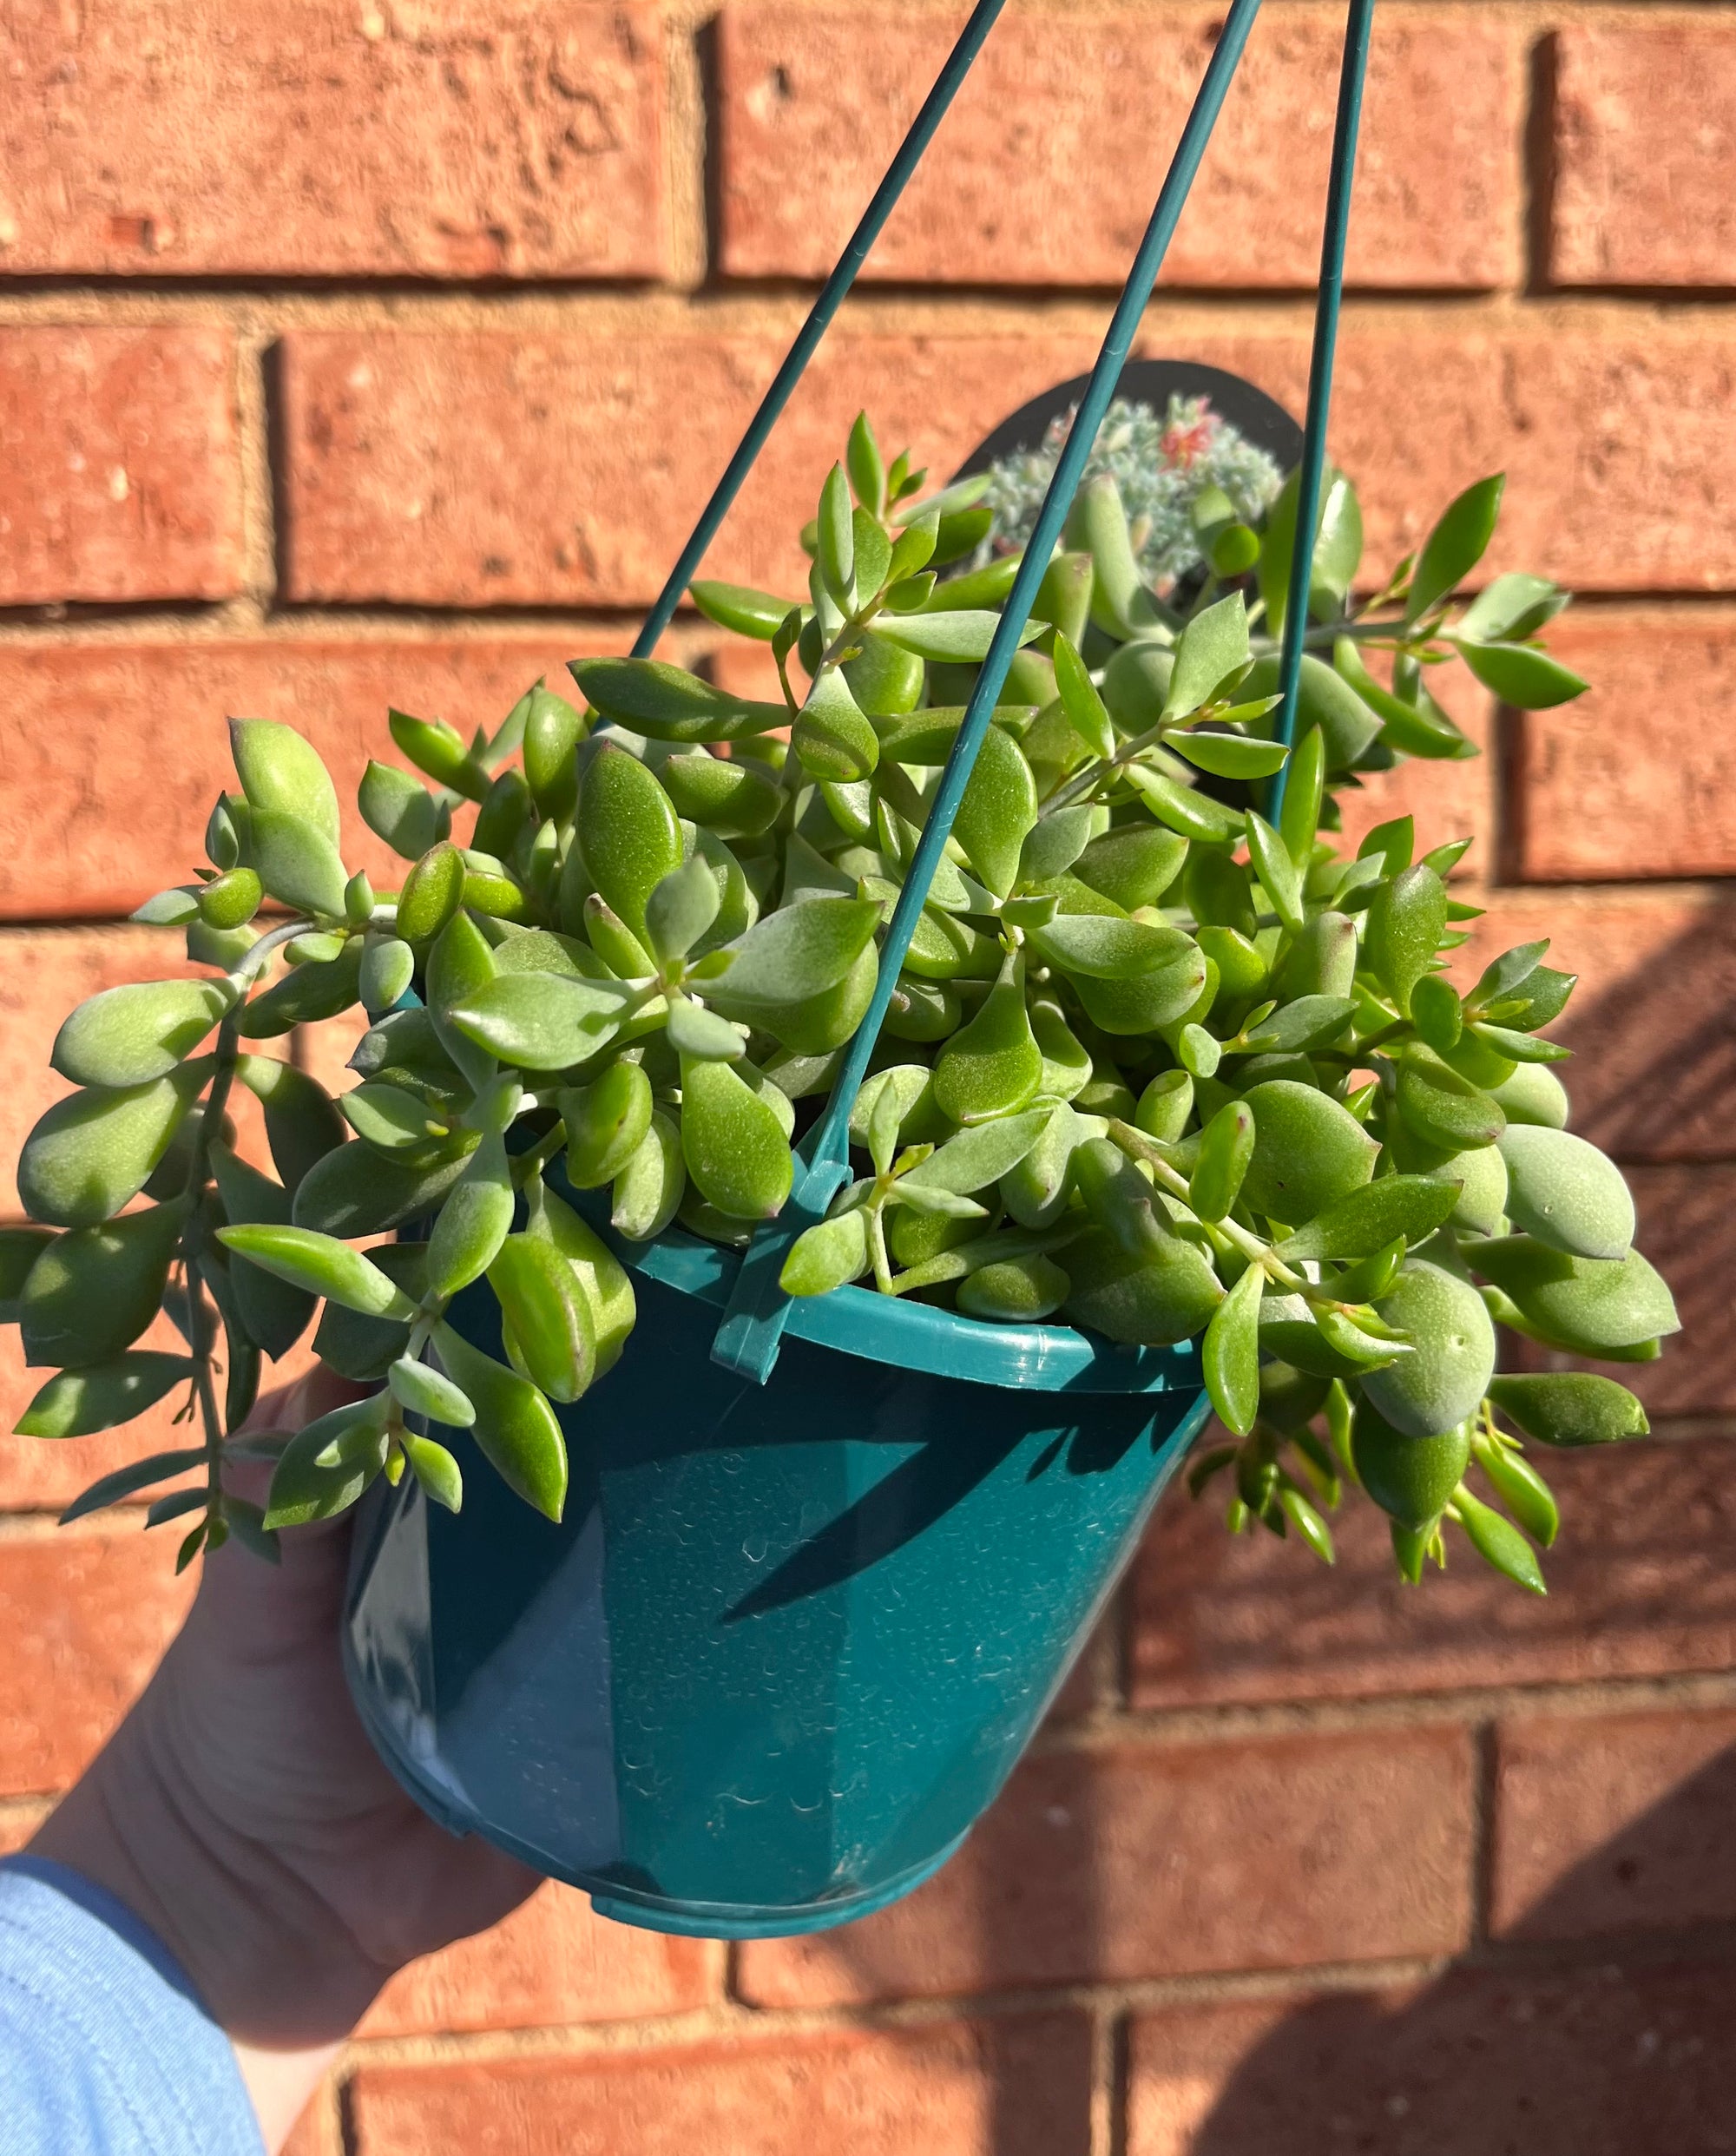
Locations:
345;1181;1206;1938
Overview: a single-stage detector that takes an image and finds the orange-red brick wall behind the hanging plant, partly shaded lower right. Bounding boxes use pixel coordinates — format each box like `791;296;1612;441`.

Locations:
0;0;1736;2156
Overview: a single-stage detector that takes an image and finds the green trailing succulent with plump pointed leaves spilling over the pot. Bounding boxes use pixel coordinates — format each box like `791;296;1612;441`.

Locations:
0;418;1675;1589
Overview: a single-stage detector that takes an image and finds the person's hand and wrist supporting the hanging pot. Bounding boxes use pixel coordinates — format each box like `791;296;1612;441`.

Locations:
30;1369;539;2150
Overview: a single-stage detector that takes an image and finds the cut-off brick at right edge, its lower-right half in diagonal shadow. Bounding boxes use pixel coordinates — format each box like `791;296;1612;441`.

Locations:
1490;1712;1736;1938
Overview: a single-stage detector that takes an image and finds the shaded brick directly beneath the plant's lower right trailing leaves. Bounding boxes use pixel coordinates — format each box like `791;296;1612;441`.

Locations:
1132;1438;1736;1707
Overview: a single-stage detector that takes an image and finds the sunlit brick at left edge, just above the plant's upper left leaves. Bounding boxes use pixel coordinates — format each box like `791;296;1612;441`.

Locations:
0;629;582;921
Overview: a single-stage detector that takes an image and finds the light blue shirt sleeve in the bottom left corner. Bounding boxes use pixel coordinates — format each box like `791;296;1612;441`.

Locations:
0;1857;266;2156
